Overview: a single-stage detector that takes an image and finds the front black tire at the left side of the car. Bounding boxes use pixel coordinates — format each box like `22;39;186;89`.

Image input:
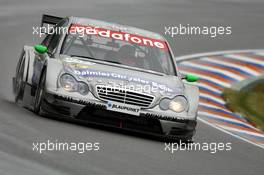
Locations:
34;69;46;115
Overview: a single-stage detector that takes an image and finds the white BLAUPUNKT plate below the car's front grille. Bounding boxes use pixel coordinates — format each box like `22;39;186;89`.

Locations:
107;101;140;116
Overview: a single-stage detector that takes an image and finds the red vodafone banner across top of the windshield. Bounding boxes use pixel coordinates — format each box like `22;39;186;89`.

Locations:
69;24;168;50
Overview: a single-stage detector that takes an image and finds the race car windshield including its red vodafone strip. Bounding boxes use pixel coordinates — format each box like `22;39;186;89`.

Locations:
61;25;175;75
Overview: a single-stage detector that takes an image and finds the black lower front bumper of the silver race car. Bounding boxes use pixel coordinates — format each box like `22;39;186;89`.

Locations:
42;93;196;138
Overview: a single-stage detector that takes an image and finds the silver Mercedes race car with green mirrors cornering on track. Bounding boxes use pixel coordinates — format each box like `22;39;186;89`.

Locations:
13;15;199;140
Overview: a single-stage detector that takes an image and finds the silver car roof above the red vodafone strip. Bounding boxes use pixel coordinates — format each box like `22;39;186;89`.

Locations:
70;17;165;40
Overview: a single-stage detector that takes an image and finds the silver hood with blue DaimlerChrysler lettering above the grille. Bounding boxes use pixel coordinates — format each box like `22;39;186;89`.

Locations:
62;57;184;98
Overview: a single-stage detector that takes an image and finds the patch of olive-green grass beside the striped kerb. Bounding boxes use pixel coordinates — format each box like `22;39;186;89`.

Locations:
223;82;264;131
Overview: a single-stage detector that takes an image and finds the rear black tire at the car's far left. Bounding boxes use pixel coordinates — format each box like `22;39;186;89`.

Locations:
15;59;25;103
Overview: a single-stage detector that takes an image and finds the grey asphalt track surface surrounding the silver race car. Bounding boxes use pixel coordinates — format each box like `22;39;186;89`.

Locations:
0;0;264;175
